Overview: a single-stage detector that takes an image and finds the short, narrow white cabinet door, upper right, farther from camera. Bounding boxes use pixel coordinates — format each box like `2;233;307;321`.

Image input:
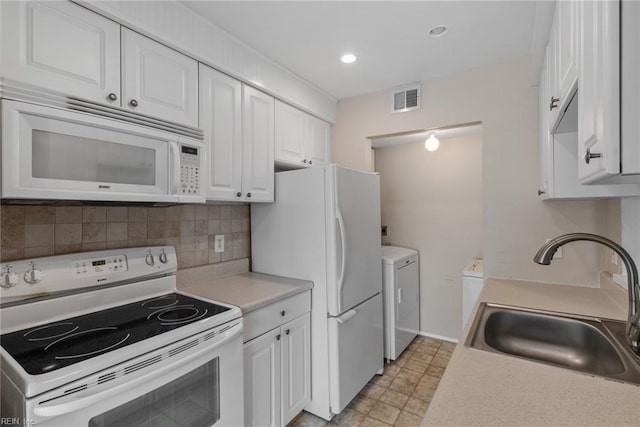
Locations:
556;0;578;105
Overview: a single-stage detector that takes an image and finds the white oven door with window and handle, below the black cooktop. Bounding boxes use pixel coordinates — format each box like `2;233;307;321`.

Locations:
26;319;244;427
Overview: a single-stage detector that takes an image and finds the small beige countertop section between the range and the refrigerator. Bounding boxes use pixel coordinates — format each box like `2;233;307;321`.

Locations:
177;272;313;314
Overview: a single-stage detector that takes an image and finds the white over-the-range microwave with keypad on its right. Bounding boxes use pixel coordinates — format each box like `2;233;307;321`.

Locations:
1;99;205;203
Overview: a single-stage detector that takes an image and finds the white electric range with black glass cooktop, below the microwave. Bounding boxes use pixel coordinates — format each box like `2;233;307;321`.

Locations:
0;247;243;427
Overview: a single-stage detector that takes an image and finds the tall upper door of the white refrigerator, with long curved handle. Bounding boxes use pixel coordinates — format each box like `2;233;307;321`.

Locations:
327;166;382;316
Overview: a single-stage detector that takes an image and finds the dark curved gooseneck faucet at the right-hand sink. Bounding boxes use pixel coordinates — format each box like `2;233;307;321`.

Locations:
533;233;640;354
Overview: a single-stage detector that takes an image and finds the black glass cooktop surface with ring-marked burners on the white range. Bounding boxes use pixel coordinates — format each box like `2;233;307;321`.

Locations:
0;293;230;375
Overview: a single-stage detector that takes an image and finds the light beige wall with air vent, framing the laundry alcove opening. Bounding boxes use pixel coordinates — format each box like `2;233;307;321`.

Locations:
332;59;619;296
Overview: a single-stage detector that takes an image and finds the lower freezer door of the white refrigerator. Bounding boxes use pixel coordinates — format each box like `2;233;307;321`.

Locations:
329;294;384;414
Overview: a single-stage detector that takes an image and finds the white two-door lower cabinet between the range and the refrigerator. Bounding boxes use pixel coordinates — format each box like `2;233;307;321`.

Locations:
243;293;311;427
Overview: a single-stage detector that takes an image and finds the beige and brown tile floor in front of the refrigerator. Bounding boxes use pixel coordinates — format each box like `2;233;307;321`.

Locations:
289;336;455;427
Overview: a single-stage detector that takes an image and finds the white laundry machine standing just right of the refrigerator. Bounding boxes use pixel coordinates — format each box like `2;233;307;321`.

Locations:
382;246;420;360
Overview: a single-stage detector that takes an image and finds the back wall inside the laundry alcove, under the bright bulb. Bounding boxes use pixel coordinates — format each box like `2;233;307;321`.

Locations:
375;134;483;339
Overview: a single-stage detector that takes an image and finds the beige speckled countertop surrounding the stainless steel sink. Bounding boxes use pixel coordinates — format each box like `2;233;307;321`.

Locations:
422;279;640;426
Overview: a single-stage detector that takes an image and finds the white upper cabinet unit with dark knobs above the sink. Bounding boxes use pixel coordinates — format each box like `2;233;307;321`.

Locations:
538;1;640;199
